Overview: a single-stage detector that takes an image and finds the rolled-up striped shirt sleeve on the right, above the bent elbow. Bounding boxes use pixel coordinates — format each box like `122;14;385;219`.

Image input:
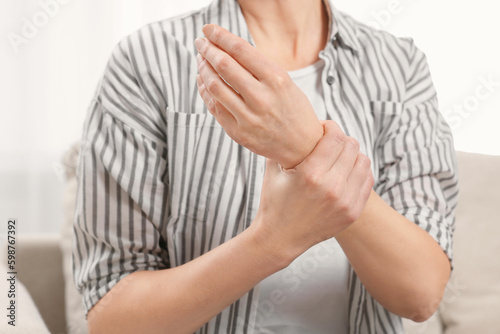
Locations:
375;44;458;261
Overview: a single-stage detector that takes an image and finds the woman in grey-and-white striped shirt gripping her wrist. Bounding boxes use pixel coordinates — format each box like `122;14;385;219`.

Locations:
74;0;457;333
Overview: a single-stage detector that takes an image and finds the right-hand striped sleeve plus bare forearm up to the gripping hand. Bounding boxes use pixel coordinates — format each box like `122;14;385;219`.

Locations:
337;41;458;321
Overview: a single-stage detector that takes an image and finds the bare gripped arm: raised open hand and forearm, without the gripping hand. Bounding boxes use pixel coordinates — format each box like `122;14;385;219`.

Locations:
198;25;456;320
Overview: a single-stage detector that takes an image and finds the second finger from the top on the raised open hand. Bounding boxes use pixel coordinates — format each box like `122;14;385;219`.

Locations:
195;38;260;100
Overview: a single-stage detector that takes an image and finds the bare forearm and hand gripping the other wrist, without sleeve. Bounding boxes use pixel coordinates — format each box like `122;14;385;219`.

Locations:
88;122;373;333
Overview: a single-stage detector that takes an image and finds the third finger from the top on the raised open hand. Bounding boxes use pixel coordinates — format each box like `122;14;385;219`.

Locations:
196;54;246;118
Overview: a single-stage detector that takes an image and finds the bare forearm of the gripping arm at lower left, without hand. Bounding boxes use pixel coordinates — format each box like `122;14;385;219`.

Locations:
88;220;291;333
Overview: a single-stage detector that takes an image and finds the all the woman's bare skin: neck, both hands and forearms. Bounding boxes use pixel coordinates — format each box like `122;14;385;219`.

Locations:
88;0;450;333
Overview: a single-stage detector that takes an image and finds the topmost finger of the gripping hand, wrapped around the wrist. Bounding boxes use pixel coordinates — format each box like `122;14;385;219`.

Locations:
299;121;346;172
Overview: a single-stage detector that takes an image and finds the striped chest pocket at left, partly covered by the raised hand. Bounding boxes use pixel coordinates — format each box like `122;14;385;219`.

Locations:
166;110;240;226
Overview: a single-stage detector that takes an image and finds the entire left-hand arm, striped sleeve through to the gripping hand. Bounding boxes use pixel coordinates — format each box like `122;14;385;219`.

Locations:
79;37;373;333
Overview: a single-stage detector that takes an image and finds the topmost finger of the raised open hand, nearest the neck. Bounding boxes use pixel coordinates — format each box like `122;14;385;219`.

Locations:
203;24;275;80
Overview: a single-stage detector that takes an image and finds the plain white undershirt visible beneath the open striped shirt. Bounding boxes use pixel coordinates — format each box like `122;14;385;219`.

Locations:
256;60;349;334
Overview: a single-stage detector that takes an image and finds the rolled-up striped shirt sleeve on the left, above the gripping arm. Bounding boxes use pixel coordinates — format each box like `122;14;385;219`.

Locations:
73;36;169;312
